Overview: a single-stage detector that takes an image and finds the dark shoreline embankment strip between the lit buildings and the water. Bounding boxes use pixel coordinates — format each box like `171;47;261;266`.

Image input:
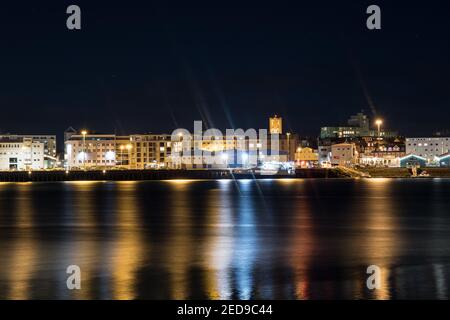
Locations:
0;167;450;182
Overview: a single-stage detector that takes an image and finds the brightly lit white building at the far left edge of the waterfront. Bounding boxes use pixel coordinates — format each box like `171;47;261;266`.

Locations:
0;137;45;171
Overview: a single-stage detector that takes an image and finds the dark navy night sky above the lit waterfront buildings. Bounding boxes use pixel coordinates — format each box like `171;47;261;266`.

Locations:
0;0;450;137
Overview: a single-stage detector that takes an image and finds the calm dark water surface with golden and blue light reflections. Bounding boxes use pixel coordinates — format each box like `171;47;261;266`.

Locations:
0;179;450;299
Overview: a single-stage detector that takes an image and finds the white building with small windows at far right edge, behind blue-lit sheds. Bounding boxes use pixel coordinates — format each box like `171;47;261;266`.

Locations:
405;137;450;162
